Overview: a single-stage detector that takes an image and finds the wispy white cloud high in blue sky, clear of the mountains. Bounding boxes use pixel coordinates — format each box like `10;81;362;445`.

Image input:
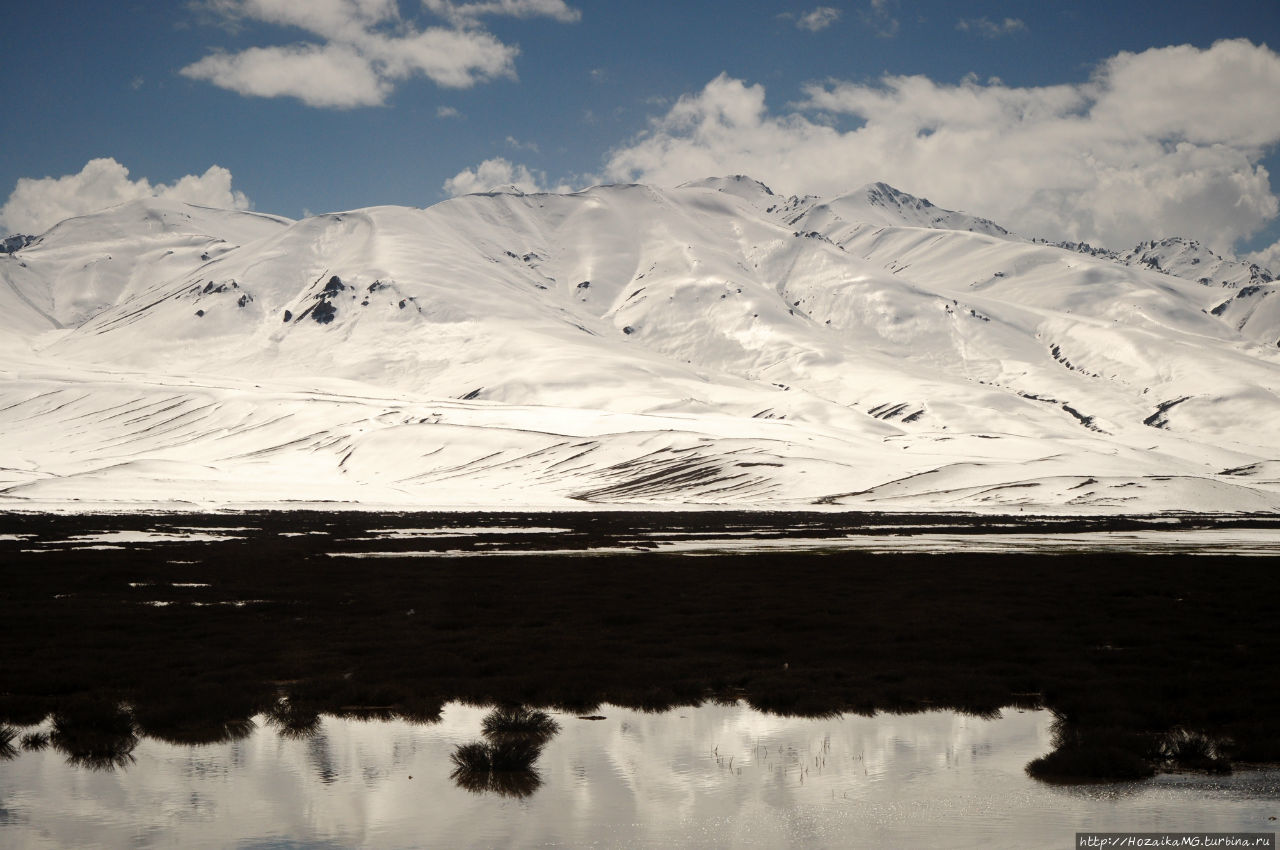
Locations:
180;0;579;109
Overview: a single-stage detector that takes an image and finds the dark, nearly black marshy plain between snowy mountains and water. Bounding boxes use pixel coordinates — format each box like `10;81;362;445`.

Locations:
0;513;1280;769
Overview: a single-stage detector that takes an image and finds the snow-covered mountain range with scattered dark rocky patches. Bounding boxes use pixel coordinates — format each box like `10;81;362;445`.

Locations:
0;177;1280;512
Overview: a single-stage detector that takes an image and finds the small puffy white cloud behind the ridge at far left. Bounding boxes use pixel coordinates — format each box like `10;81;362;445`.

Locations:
0;157;250;233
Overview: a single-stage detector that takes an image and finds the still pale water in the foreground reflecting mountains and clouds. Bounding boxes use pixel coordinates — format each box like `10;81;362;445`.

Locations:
0;704;1280;849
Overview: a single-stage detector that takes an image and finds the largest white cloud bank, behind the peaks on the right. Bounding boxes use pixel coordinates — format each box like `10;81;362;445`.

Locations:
605;40;1280;251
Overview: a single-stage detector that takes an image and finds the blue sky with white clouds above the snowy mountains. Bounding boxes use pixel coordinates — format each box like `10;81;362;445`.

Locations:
0;0;1280;265
